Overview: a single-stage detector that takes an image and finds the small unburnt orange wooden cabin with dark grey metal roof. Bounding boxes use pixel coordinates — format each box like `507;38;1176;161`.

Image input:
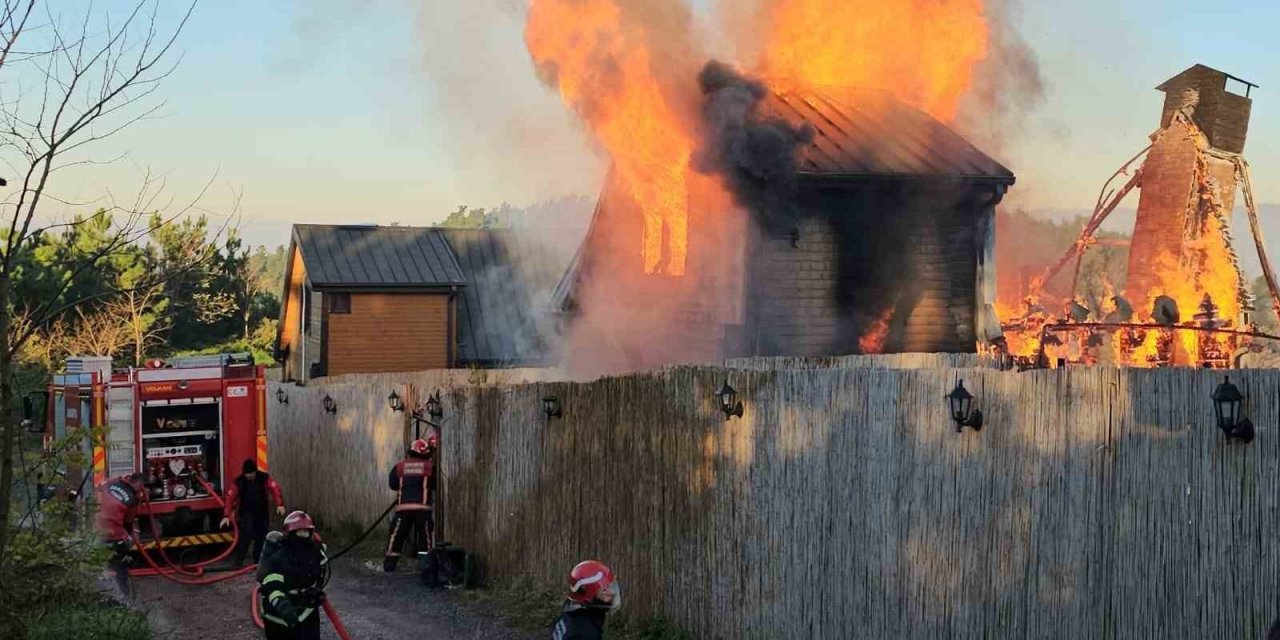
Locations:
276;224;563;381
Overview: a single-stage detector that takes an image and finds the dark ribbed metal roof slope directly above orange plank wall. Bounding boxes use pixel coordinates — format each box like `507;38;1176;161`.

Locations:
293;224;466;288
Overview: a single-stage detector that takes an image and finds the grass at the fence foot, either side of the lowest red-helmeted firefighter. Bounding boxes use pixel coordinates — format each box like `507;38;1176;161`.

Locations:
452;577;692;640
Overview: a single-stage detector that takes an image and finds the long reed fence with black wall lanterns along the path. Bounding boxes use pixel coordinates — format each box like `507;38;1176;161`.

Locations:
270;362;1280;640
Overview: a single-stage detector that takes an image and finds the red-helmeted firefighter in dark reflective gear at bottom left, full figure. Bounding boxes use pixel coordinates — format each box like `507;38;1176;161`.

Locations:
256;511;329;640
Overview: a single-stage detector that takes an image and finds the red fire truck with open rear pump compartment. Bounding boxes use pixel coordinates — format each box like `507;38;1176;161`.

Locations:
44;353;268;548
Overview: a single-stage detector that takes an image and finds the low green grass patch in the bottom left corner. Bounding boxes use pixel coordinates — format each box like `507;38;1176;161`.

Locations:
18;596;152;640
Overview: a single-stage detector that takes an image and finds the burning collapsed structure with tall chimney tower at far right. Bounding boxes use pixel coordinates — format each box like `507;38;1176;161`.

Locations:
1002;65;1280;367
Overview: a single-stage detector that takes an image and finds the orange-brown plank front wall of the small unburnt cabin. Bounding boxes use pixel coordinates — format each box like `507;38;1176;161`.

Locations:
325;293;452;375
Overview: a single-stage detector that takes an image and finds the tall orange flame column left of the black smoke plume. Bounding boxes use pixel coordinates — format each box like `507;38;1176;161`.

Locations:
525;0;692;275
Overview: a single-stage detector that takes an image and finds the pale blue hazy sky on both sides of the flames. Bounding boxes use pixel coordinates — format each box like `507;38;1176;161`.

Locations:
32;0;1280;252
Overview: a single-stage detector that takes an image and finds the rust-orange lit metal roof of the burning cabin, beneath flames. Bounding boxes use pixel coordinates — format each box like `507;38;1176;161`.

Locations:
762;88;1014;184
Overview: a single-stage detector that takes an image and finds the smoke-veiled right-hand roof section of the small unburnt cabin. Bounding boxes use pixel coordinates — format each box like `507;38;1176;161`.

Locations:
439;229;567;366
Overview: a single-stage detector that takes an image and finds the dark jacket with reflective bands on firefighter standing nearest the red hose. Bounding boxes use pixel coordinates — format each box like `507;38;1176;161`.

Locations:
257;534;329;627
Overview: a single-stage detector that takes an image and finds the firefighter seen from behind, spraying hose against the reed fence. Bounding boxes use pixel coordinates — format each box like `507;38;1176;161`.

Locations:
383;430;440;573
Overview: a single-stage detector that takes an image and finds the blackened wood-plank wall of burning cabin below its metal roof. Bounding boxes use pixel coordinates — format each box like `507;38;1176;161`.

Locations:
742;183;984;356
